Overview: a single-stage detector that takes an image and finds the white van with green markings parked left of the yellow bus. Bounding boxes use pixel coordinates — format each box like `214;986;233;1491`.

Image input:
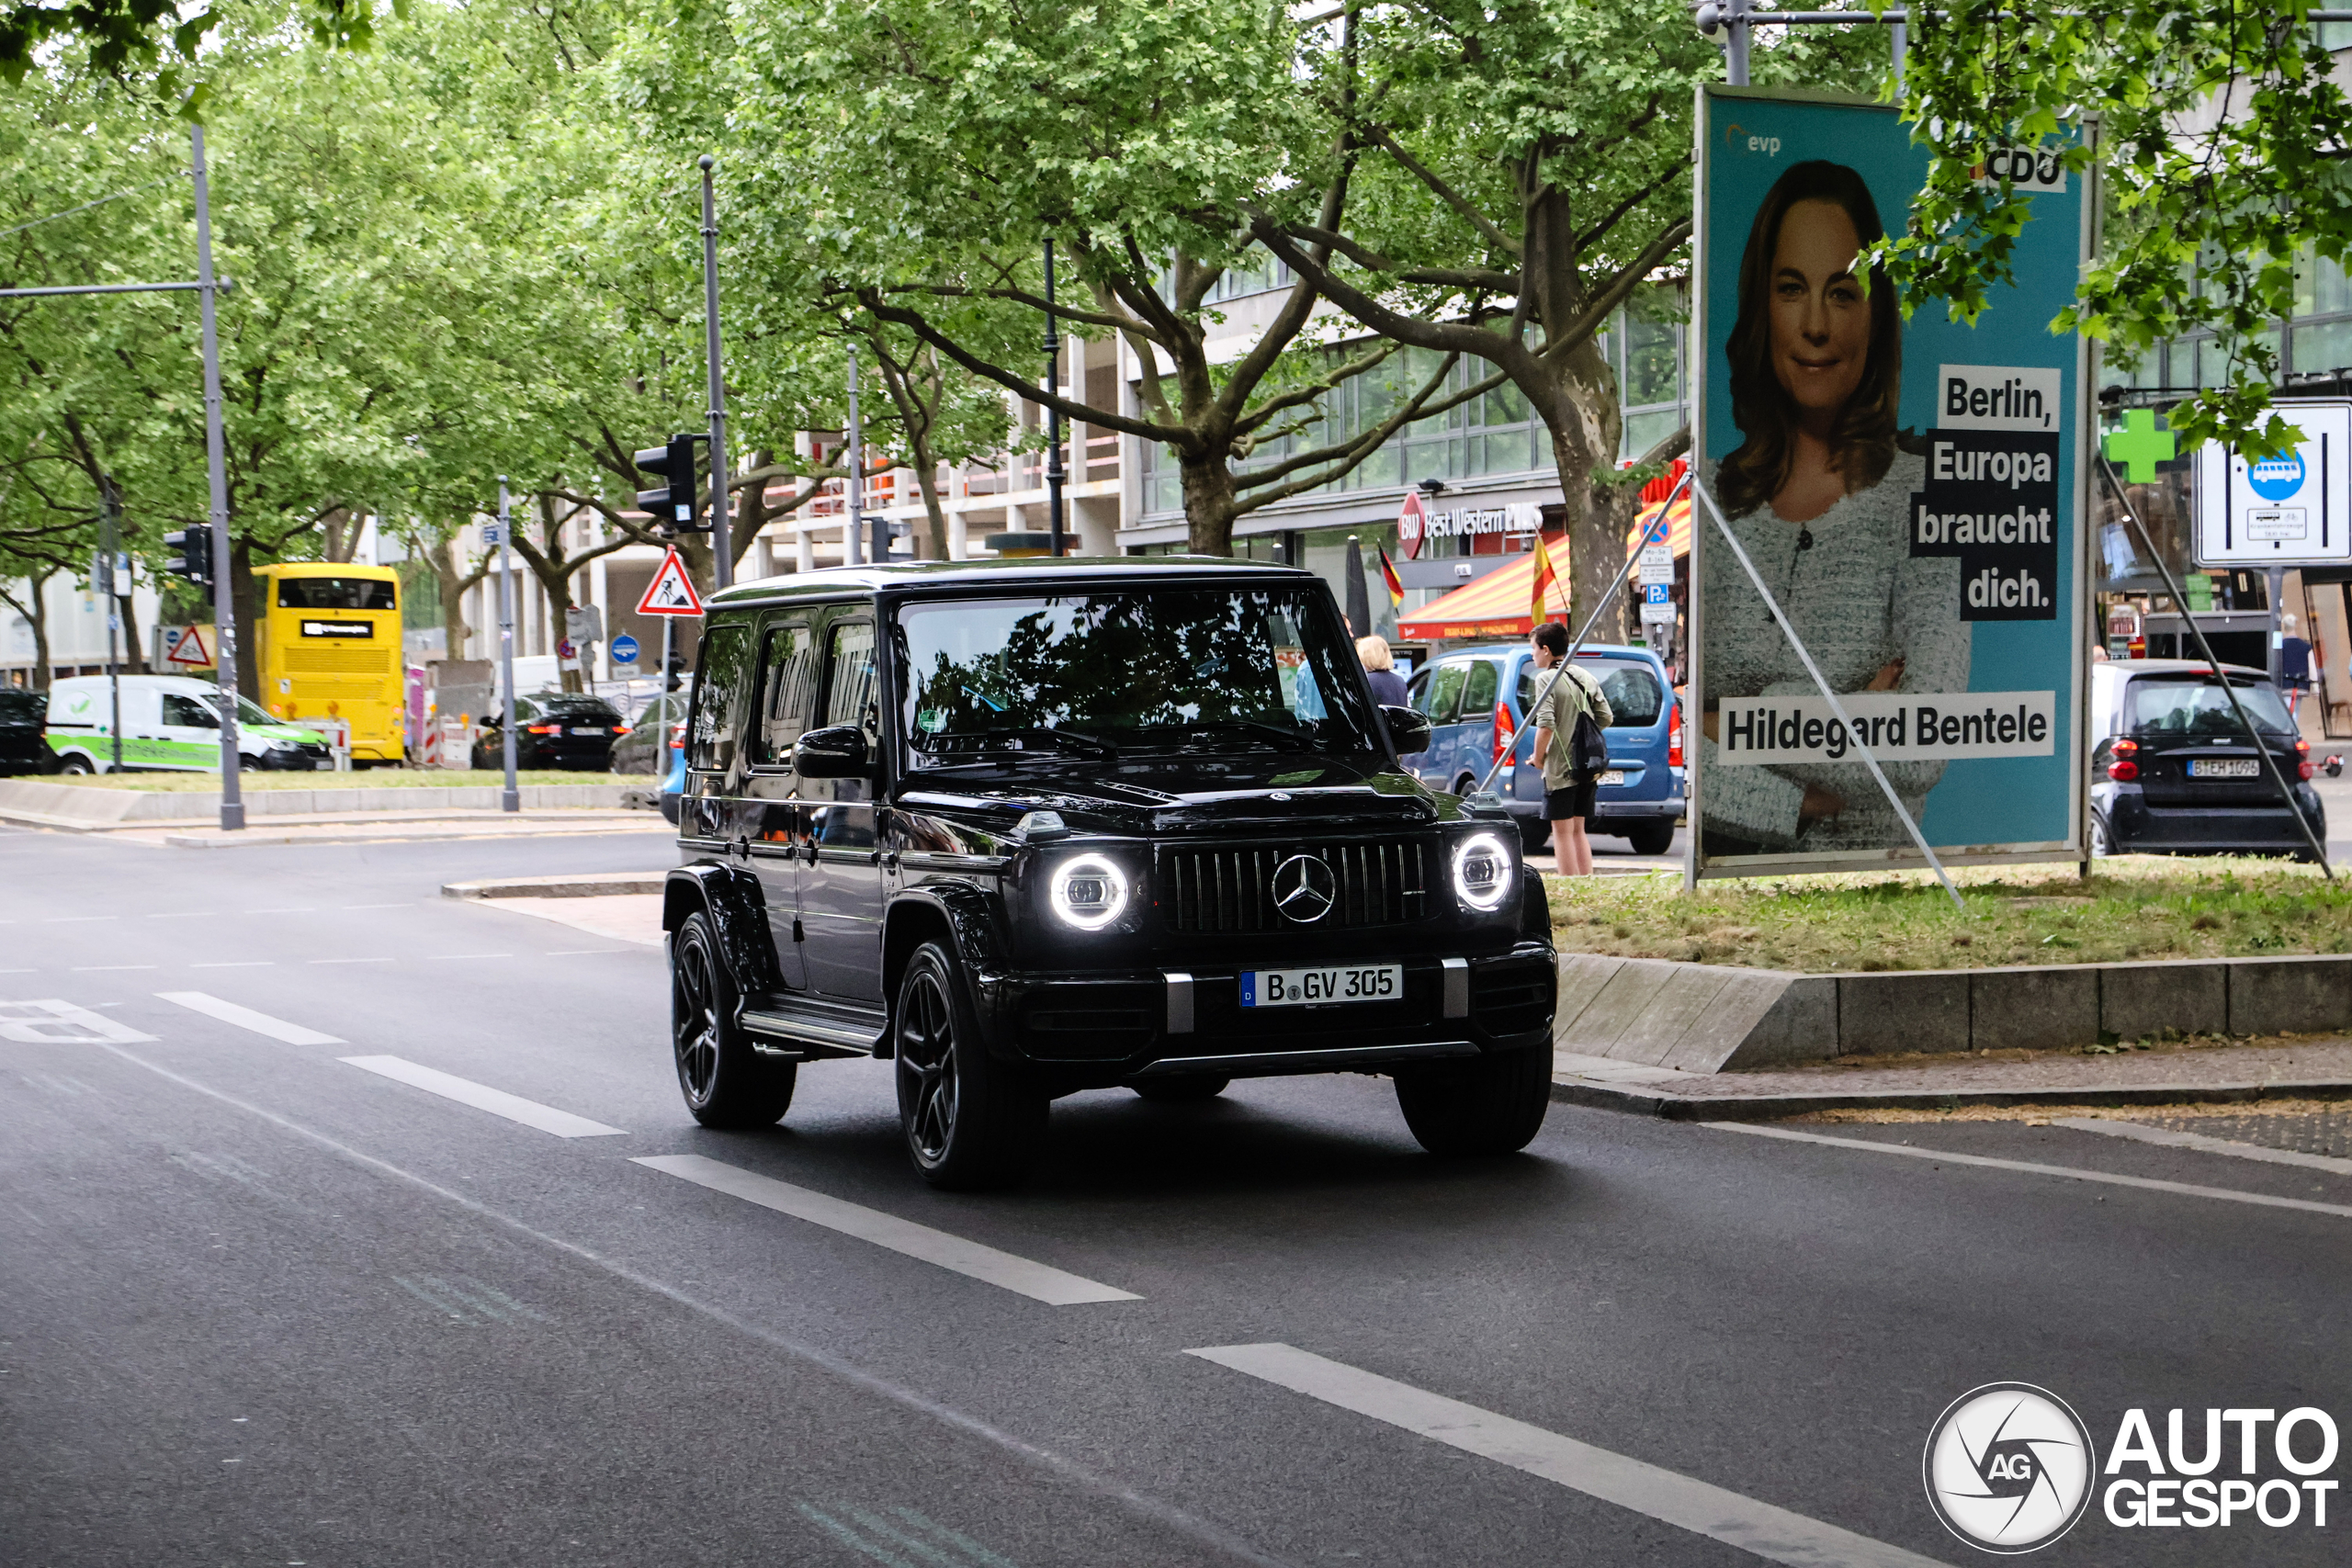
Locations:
47;674;332;773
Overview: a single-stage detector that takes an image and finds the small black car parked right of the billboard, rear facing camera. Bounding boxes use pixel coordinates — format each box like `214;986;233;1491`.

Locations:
2091;659;2328;858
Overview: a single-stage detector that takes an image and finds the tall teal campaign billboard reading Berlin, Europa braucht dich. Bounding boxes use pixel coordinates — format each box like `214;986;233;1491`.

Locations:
1687;87;2088;877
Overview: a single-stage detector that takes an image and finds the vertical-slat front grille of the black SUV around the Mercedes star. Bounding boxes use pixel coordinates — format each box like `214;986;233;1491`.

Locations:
1159;840;1428;933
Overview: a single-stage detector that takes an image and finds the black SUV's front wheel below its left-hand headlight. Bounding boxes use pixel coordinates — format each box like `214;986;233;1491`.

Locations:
891;942;1051;1192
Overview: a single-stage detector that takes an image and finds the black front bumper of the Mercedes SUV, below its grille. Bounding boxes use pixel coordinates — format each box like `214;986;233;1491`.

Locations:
974;941;1557;1089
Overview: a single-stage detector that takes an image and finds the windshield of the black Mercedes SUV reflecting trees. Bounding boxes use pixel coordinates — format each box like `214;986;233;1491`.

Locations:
899;588;1376;766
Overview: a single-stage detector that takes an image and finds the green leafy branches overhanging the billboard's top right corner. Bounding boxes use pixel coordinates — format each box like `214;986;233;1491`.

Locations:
1884;0;2352;454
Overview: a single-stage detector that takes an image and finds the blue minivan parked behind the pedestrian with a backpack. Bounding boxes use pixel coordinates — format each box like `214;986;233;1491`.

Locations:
1404;644;1684;856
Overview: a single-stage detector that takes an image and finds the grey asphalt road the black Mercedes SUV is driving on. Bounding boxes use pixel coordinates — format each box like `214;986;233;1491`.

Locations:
0;832;2352;1568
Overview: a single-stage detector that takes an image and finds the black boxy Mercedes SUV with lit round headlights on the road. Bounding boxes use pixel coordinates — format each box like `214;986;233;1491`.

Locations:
661;558;1555;1187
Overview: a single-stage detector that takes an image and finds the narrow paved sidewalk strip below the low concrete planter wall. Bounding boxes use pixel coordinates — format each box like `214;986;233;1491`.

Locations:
1553;1034;2352;1122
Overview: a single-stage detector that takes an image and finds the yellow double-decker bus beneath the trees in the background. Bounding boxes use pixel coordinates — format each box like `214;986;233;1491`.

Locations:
254;562;407;764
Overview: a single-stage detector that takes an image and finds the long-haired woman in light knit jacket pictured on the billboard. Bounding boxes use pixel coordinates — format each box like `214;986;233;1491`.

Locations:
1701;160;1971;858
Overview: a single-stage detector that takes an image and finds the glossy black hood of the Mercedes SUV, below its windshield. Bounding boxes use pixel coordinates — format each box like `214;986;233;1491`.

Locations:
896;755;1463;835
